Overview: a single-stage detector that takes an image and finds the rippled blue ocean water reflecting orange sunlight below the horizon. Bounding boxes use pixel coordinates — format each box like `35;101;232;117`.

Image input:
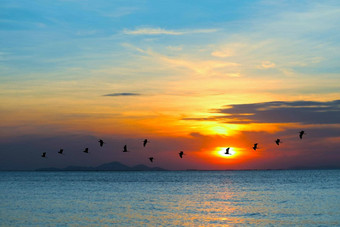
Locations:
0;170;340;226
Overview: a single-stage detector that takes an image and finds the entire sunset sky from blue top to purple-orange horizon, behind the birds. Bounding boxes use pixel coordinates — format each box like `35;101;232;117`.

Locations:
0;0;340;170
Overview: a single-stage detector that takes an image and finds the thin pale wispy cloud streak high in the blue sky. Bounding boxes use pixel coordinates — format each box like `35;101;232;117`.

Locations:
123;27;218;35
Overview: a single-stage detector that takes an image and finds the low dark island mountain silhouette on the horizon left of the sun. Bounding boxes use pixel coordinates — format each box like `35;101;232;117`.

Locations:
36;162;166;171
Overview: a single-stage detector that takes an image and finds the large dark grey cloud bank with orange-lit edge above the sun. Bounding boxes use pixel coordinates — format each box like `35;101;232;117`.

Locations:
183;100;340;124
